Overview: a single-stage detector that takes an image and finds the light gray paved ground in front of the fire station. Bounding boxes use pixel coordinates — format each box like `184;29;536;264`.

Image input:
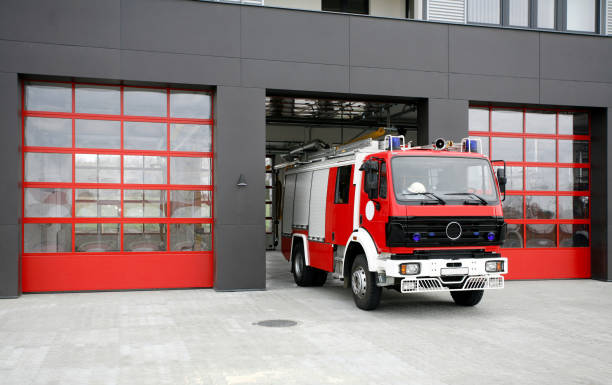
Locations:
0;253;612;385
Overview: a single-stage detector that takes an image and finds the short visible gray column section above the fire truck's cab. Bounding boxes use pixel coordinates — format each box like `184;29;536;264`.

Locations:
417;99;469;145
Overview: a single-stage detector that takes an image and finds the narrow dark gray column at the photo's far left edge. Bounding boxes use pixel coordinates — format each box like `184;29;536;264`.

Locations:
0;72;21;298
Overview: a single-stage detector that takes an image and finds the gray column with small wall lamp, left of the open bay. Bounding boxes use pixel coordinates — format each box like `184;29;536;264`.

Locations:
214;87;266;290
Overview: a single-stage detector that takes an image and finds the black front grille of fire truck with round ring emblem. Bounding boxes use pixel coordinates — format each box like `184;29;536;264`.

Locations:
386;217;506;247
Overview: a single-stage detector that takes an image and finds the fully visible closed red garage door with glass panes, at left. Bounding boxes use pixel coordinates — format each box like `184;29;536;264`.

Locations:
22;82;213;292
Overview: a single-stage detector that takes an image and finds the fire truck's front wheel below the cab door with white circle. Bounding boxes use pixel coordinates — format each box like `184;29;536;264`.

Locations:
351;254;382;310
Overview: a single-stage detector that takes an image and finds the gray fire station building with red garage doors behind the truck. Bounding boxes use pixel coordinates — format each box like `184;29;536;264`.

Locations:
0;0;612;298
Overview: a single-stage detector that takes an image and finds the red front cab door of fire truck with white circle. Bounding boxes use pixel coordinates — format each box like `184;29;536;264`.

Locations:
359;159;389;247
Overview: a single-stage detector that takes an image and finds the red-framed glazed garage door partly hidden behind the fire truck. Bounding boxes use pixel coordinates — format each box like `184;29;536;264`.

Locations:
469;106;591;279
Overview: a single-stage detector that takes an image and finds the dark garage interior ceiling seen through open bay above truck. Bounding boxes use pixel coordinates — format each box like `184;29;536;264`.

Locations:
266;96;417;153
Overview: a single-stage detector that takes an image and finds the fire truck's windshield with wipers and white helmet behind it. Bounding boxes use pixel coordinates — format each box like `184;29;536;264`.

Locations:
391;156;498;205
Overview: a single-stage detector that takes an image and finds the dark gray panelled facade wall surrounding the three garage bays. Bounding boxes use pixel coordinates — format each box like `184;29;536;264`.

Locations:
0;0;612;297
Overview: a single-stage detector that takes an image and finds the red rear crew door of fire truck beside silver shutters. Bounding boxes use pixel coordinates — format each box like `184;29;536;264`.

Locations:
325;165;355;246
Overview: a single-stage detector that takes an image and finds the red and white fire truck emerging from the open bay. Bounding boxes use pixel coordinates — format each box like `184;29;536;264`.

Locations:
276;135;508;310
